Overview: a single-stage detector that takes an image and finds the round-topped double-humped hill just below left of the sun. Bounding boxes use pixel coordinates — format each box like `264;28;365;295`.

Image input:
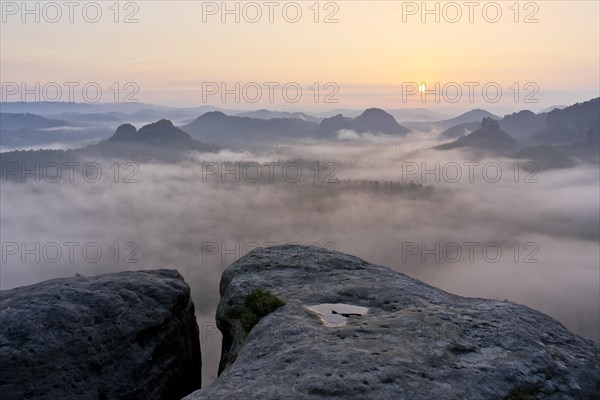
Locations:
319;108;410;137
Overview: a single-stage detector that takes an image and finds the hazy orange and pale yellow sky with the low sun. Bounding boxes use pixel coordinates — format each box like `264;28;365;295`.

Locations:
1;1;600;110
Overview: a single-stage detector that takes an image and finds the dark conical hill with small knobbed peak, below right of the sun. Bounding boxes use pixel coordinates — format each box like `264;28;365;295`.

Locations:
436;117;518;153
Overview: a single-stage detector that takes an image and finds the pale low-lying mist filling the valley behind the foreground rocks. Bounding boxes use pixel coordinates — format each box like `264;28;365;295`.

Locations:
0;132;600;386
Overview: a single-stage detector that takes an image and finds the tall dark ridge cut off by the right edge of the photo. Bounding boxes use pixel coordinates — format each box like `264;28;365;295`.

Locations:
533;97;600;146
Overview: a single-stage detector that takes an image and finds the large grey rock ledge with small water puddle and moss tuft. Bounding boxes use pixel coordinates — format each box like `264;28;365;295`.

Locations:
185;245;600;400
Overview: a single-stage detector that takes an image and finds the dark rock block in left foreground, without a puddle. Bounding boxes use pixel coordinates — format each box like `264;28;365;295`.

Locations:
0;270;201;400
